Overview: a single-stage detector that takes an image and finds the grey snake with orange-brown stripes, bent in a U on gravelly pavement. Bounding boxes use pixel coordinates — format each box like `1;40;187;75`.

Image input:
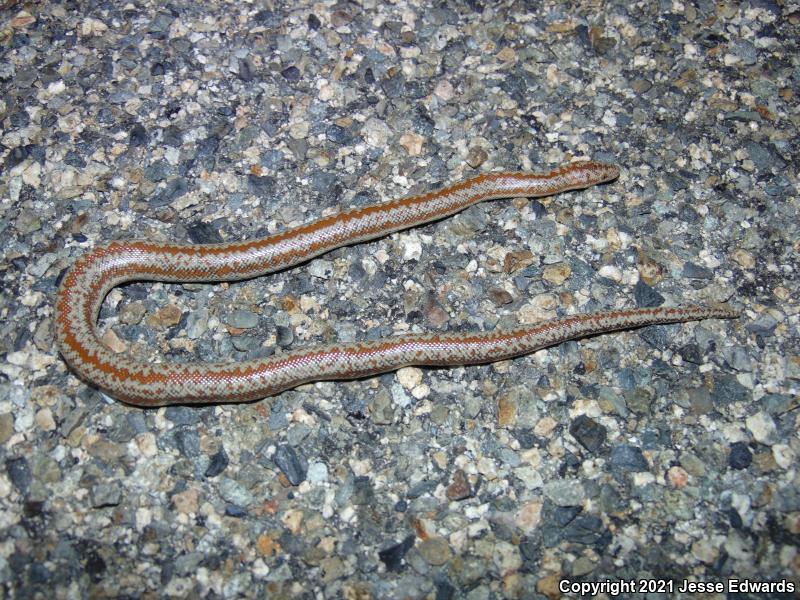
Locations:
53;160;737;407
